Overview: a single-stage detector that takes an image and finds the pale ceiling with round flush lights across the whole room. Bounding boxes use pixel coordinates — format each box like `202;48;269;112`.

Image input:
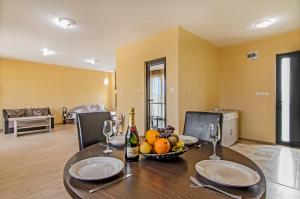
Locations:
0;0;300;71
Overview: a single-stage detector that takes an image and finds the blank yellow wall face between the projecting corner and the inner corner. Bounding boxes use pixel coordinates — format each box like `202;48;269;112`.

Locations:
178;28;220;132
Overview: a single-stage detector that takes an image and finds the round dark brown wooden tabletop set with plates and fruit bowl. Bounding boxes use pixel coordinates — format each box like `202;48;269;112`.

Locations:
64;144;266;199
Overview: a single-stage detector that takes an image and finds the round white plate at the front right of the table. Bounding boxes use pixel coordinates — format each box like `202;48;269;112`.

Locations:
195;160;260;187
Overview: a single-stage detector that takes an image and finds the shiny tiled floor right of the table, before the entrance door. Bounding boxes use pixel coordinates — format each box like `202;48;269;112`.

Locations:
231;143;300;198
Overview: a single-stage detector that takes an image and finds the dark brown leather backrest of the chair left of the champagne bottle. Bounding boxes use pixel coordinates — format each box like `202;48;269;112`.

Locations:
76;112;111;150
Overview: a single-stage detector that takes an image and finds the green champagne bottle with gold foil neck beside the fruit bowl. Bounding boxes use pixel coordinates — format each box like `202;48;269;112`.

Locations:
125;108;139;161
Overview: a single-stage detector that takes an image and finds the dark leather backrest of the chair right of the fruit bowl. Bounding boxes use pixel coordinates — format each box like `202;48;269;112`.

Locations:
183;111;223;141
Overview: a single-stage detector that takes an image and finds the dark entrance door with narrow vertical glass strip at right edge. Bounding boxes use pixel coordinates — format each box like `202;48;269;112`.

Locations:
276;51;300;146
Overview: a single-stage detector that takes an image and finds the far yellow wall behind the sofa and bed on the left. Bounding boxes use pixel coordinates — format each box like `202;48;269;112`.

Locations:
0;59;112;128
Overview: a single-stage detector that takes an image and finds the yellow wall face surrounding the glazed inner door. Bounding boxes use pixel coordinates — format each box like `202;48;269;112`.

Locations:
117;27;178;134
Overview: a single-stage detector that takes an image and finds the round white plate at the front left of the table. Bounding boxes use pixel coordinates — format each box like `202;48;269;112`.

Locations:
69;157;124;180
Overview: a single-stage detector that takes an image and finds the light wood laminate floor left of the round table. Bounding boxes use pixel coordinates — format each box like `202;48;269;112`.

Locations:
0;125;78;199
